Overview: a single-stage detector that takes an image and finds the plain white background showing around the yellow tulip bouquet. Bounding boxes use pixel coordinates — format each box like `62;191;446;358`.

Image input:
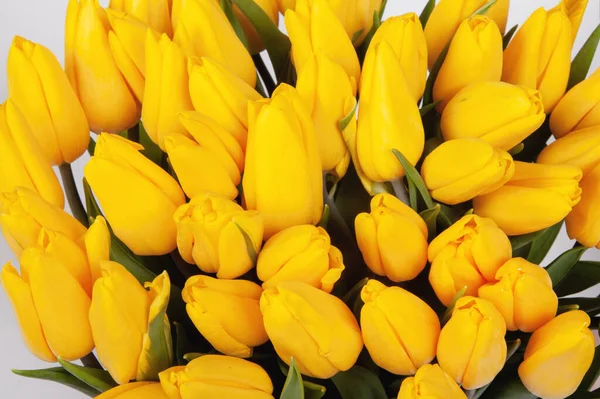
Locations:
0;0;600;399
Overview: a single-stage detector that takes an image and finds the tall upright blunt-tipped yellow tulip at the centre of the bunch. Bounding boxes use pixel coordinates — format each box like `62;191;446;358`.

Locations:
242;84;323;238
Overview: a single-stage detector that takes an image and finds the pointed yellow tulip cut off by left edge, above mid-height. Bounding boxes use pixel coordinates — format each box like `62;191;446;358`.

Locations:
0;100;65;208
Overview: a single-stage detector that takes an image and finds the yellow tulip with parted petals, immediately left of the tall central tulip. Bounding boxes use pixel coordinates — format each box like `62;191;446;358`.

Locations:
164;111;244;199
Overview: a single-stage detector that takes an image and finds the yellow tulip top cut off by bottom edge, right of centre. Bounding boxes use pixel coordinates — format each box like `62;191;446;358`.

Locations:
398;364;467;399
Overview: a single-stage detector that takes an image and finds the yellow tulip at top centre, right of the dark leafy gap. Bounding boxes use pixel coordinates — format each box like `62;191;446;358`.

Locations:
285;0;360;84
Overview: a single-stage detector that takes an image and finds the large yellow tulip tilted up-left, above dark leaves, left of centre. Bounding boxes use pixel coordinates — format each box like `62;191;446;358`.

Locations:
84;133;185;255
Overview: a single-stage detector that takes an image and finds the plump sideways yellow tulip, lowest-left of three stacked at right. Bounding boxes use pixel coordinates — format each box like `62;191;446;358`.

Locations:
421;139;515;205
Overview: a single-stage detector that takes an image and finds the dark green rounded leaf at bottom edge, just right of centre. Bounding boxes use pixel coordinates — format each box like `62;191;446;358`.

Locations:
331;366;388;399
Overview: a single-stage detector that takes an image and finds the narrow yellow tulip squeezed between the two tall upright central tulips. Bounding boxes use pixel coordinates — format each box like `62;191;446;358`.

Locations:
296;53;356;178
